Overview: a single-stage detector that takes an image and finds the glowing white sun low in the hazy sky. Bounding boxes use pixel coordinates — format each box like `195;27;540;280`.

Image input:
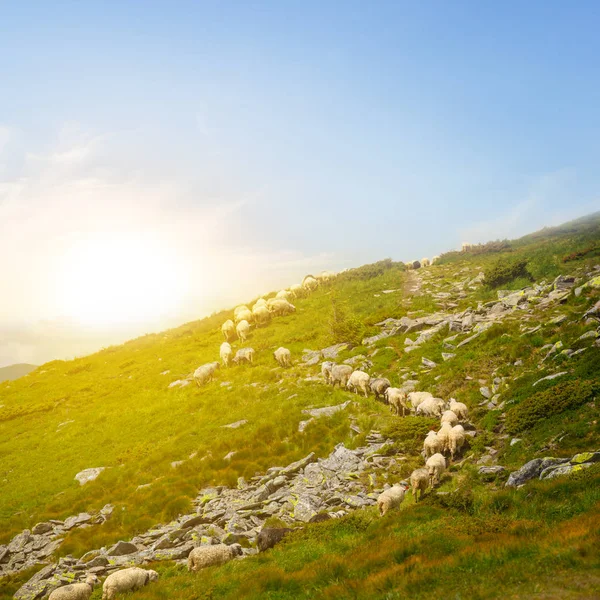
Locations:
57;234;185;326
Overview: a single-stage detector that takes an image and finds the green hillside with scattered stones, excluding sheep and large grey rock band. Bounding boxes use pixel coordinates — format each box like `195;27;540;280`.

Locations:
0;213;600;599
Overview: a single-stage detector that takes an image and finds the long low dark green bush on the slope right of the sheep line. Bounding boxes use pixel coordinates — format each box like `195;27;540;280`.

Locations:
506;381;597;434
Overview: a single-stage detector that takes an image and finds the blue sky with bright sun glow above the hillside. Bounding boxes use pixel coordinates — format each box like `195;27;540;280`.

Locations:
0;0;600;366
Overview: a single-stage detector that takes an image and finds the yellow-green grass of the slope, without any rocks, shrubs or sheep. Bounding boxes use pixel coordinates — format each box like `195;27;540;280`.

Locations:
0;213;600;598
